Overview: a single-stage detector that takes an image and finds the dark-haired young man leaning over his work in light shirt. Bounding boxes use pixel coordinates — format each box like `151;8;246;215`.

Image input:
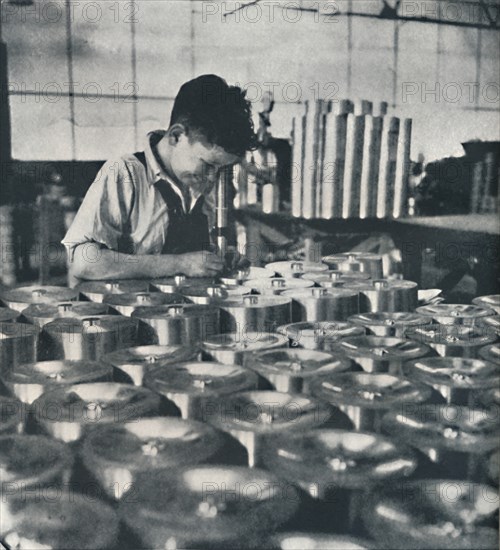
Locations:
62;75;255;280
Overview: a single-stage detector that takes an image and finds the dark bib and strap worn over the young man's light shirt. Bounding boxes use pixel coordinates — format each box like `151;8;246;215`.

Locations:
134;152;210;254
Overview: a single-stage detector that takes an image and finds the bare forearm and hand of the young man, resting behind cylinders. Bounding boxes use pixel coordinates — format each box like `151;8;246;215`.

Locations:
71;243;224;280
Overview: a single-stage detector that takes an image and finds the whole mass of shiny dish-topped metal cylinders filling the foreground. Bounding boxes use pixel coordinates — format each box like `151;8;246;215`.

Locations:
0;260;500;549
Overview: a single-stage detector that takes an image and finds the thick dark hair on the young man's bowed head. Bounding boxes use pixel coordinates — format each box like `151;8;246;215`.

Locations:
170;74;256;156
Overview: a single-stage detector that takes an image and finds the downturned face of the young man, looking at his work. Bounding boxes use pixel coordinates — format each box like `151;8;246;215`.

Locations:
170;133;240;194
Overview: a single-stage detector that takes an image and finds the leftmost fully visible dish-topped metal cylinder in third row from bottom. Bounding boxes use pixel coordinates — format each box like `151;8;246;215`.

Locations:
31;382;162;443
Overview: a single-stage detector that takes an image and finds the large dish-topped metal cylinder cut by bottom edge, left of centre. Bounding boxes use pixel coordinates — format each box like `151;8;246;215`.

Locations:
119;465;298;549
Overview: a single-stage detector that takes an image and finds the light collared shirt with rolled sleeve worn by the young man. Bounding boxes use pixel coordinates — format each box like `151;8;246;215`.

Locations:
61;130;215;262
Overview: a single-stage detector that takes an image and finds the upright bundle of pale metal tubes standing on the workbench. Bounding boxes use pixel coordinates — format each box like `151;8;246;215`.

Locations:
291;100;412;219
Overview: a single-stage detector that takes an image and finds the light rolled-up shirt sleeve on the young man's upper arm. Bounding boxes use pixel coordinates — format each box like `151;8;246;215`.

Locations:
61;159;134;262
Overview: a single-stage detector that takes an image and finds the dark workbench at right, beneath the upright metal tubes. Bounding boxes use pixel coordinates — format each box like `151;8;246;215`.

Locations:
234;207;500;300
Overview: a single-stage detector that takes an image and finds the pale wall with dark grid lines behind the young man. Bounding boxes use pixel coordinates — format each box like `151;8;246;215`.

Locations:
2;0;500;165
